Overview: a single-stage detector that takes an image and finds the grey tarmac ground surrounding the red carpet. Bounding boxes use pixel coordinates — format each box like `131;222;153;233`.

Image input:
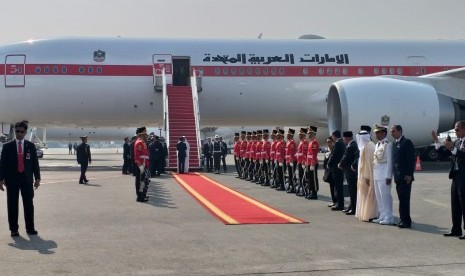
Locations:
0;149;465;276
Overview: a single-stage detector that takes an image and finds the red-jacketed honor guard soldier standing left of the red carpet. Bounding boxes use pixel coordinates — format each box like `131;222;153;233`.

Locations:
134;127;150;202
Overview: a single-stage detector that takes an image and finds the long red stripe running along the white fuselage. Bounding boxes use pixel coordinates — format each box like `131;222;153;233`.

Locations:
0;64;461;78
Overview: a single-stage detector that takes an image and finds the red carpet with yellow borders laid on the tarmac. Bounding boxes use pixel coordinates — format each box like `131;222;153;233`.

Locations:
174;173;307;224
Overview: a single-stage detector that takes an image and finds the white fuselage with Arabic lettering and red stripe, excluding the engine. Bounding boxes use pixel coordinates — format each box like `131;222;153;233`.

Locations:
0;38;465;127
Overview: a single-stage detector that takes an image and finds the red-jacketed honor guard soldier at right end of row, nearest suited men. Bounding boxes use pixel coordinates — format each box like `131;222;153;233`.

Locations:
306;126;320;199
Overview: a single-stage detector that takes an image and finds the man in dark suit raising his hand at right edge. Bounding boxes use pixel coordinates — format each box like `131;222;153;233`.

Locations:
432;121;465;240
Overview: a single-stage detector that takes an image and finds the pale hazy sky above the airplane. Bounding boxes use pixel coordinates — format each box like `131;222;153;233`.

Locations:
0;0;465;44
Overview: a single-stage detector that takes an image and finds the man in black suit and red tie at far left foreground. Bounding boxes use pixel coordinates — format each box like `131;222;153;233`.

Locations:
0;121;40;237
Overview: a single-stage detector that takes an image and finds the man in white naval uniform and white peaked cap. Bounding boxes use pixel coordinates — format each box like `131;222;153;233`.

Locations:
373;125;394;225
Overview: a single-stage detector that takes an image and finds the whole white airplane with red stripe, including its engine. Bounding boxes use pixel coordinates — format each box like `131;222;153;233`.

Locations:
0;37;465;150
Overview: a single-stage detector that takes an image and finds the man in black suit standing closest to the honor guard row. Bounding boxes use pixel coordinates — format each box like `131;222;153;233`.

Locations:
328;130;346;211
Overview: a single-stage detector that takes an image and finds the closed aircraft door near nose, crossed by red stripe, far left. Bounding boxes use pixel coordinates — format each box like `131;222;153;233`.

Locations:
5;55;26;87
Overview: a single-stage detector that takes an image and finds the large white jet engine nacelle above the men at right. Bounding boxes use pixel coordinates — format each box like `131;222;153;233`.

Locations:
328;77;462;146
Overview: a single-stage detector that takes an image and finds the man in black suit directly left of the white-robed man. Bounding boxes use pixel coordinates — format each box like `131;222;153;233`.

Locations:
338;131;359;215
